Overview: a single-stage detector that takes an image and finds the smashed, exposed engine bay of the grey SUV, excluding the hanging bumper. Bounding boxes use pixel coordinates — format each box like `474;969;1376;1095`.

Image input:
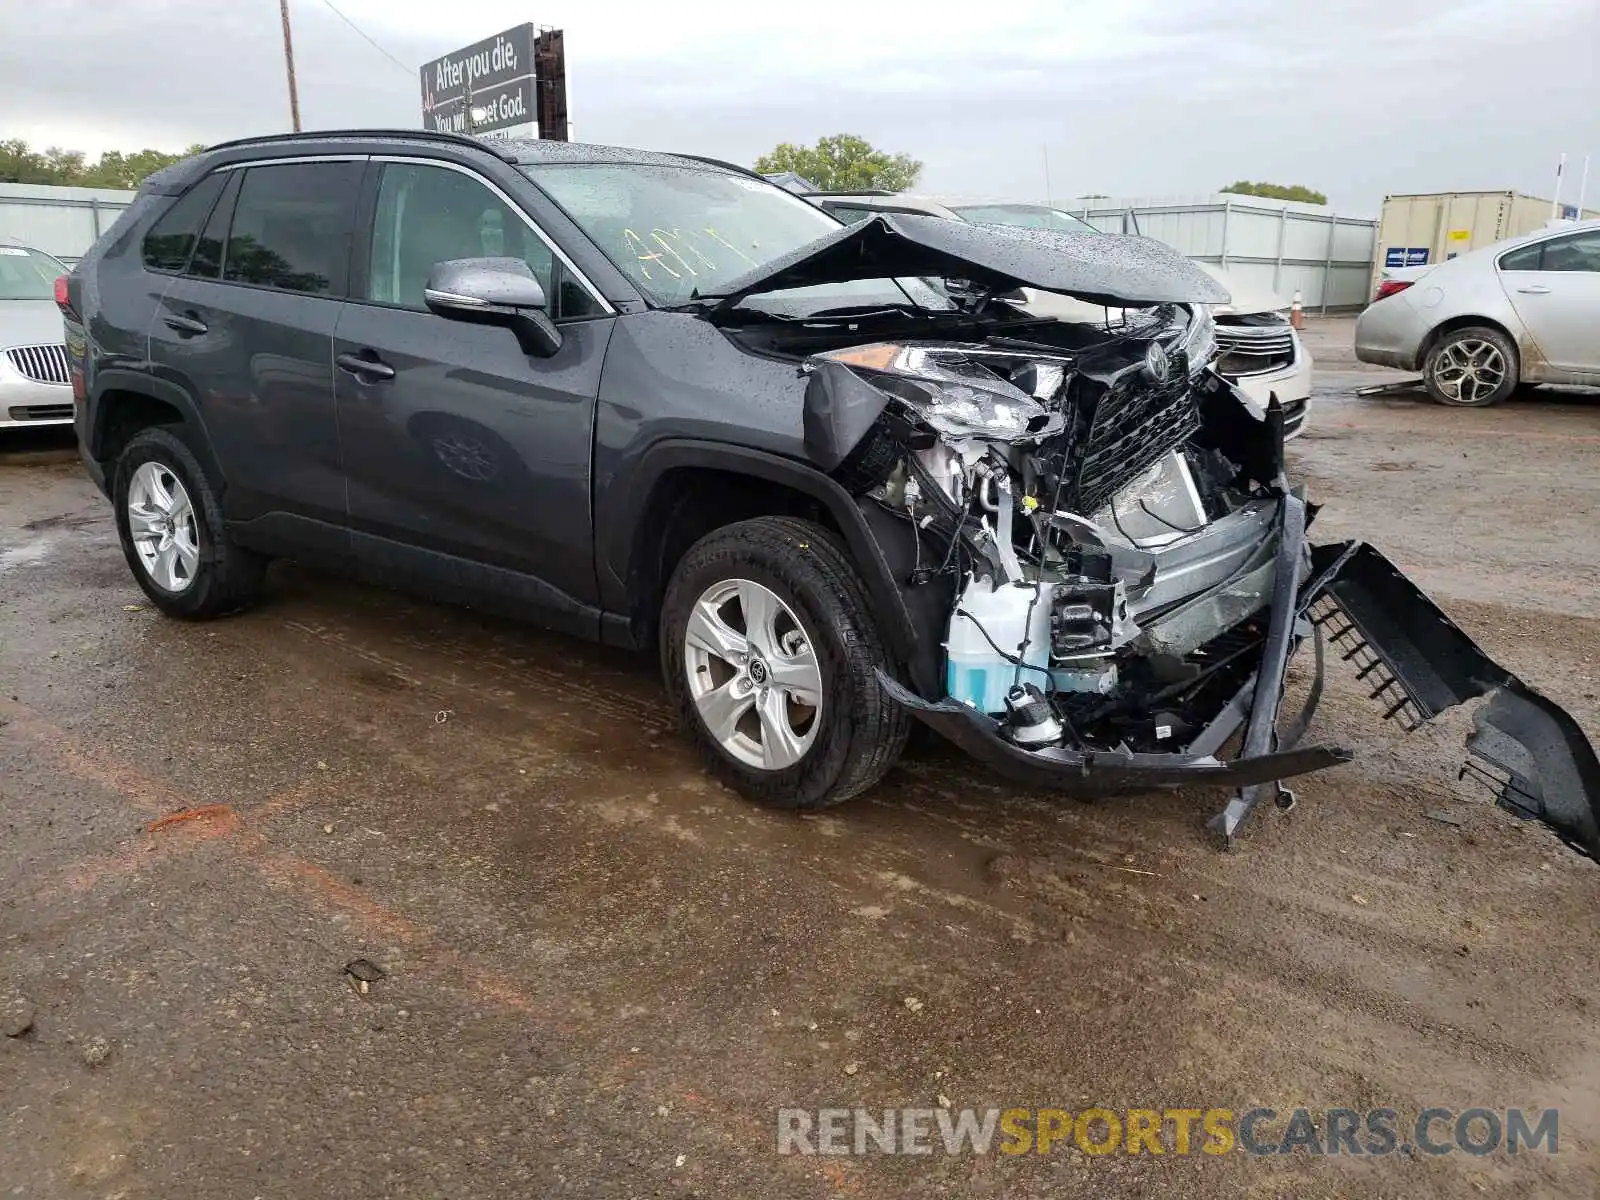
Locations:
805;306;1280;752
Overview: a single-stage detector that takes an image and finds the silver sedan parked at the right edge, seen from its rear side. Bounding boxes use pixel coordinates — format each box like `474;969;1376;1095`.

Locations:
1355;221;1600;408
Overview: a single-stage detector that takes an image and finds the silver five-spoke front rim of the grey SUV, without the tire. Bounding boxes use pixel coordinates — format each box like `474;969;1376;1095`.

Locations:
683;579;822;771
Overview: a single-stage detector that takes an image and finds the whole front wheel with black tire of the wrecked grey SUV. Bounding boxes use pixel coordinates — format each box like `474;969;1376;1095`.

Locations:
661;517;910;810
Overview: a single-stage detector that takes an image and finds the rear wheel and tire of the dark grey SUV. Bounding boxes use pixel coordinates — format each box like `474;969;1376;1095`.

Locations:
112;426;267;619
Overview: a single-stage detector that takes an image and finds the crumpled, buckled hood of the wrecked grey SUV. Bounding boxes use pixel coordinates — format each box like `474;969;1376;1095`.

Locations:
714;213;1229;312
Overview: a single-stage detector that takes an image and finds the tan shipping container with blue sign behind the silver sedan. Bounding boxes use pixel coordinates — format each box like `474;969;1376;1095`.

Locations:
1373;192;1600;291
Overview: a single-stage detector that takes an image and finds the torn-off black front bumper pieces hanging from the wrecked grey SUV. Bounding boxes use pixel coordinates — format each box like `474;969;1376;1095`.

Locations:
878;496;1600;858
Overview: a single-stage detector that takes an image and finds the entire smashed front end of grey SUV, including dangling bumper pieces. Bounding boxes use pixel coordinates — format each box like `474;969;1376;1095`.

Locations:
805;315;1600;856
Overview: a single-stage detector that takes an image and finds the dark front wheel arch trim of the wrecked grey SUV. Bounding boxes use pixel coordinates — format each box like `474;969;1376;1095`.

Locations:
598;438;931;688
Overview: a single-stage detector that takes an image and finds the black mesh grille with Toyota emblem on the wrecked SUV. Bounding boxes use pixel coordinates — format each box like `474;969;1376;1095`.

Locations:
1077;354;1200;512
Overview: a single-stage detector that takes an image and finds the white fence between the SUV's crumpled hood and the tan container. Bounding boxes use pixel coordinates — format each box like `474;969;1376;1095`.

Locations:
1056;195;1378;312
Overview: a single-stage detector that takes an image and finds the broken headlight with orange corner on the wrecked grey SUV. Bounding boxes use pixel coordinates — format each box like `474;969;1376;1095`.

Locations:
818;342;1064;442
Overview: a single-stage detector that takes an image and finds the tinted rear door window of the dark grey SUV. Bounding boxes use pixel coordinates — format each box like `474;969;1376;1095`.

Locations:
222;162;365;296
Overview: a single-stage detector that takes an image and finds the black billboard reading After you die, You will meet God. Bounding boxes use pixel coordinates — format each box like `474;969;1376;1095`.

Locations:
422;22;536;133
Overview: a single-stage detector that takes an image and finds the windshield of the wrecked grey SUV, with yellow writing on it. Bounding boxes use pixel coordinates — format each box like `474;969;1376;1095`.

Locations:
523;163;950;317
